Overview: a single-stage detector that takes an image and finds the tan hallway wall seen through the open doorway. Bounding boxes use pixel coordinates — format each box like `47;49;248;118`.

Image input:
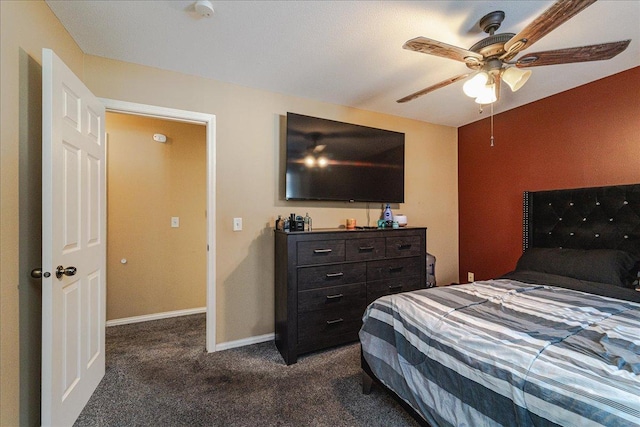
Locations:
106;113;207;320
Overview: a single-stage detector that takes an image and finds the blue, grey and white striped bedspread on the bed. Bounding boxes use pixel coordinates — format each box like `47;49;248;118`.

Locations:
360;279;640;426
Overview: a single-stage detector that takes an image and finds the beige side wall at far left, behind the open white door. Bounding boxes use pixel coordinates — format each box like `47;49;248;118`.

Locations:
0;0;83;426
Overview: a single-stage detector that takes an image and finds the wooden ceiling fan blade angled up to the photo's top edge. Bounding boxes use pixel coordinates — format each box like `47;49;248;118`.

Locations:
501;0;596;61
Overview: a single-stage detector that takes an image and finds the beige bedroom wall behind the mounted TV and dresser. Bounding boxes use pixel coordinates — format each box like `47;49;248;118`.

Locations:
85;55;458;343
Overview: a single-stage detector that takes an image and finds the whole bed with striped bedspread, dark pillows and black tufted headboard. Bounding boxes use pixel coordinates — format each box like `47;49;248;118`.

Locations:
360;184;640;426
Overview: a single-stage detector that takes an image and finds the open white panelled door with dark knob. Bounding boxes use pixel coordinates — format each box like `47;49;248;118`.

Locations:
42;49;106;426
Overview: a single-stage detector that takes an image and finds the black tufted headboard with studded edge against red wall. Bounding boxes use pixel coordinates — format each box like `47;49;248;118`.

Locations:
522;184;640;255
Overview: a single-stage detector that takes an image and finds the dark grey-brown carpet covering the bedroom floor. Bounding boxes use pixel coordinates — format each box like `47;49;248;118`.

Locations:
75;315;417;426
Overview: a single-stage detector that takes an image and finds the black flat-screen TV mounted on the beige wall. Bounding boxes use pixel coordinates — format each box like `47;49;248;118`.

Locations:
286;113;404;203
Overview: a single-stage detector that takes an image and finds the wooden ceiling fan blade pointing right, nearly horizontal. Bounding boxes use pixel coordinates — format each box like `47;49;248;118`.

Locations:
516;40;631;68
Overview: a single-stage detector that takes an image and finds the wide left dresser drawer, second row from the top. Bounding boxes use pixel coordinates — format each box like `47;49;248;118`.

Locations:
298;262;367;291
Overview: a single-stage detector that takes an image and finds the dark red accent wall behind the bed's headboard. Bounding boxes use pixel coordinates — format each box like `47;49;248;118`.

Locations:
458;67;640;282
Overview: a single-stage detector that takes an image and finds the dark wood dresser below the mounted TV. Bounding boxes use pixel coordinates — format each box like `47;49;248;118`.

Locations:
275;227;427;365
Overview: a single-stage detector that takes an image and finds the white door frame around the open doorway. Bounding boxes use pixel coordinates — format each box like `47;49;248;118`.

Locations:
98;98;216;353
